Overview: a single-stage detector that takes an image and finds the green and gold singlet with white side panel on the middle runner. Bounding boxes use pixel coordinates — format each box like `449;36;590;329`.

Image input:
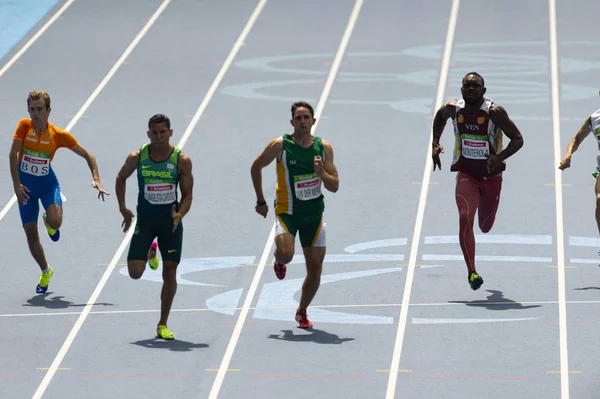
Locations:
275;134;325;215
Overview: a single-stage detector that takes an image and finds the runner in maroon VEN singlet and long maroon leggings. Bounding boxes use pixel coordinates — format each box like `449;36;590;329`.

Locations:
432;72;523;290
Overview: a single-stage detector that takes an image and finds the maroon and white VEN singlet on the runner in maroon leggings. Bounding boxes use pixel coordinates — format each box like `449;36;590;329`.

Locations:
450;97;506;177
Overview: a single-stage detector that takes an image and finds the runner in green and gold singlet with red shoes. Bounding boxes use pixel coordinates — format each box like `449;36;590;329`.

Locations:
250;101;339;328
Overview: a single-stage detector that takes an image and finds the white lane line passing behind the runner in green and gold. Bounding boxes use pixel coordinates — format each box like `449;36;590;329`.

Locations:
208;0;363;399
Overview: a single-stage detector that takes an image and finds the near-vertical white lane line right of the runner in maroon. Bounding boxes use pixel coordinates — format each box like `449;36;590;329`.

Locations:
548;0;569;399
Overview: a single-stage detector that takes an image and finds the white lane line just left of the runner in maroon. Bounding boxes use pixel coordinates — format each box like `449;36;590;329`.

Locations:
385;0;460;399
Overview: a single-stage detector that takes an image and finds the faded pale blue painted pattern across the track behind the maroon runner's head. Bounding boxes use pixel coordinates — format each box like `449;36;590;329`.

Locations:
221;41;600;113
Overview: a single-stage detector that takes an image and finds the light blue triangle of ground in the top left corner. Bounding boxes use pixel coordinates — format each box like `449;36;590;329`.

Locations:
0;0;58;59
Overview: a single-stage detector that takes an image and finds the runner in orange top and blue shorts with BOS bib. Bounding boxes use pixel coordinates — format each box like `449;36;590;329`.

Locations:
10;91;108;293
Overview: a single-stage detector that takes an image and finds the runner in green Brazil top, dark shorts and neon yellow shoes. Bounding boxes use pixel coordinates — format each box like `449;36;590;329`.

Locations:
115;114;194;339
